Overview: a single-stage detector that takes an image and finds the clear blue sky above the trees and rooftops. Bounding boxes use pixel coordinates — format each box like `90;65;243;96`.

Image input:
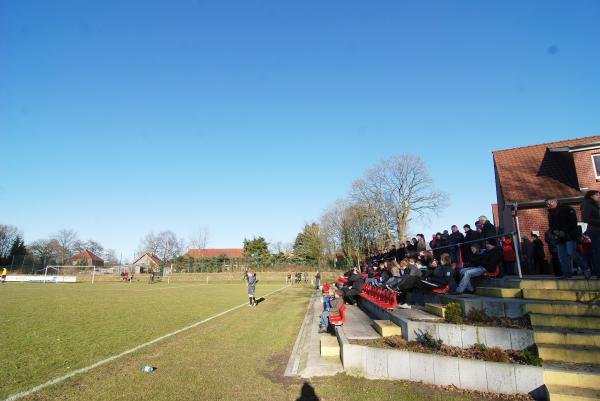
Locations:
0;0;600;258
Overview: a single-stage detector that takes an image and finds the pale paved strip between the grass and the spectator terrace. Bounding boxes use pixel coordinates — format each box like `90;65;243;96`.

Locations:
285;291;344;378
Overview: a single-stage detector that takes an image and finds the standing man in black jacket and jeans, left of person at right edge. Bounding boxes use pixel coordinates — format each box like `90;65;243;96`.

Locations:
546;198;591;278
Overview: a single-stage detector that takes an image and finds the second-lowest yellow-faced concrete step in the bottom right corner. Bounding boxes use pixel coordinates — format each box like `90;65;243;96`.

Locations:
544;363;600;390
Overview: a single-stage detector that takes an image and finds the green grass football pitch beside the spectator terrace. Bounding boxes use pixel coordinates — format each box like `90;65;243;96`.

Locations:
0;283;510;401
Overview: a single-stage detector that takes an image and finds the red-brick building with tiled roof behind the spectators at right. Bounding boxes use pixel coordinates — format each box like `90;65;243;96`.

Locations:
492;136;600;268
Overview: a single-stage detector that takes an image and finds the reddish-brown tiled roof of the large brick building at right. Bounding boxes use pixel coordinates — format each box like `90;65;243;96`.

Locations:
492;135;600;203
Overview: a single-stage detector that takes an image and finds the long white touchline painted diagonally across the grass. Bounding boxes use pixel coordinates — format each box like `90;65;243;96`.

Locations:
4;285;289;401
